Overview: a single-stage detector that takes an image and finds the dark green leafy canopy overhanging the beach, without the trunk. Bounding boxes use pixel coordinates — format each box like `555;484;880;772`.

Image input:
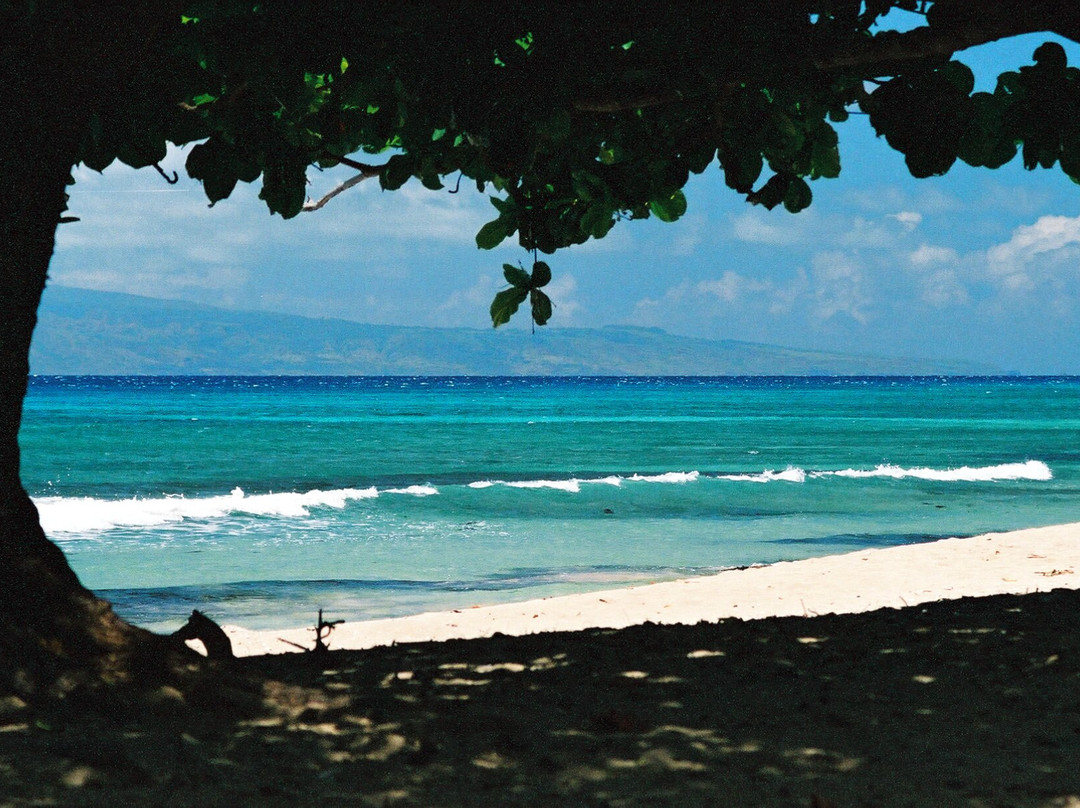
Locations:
44;0;1080;325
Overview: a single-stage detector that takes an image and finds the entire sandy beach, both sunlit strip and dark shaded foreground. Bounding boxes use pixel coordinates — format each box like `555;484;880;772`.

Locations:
0;525;1080;808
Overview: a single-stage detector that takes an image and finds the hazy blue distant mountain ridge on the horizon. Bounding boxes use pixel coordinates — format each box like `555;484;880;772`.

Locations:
30;286;995;376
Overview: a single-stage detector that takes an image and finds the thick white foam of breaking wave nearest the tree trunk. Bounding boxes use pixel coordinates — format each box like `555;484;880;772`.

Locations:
35;488;379;534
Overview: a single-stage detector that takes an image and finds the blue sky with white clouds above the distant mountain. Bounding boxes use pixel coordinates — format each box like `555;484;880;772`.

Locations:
46;27;1080;374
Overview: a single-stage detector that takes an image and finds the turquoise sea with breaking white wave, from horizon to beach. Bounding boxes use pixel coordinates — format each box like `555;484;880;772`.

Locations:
21;377;1080;630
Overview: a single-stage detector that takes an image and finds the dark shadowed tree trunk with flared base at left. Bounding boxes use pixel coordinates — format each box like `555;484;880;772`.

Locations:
0;2;183;697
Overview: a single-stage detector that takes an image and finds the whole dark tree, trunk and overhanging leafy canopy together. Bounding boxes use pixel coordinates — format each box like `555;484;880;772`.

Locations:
0;0;1080;693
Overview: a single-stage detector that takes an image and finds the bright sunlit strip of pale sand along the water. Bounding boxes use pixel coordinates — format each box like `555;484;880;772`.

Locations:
222;522;1080;657
